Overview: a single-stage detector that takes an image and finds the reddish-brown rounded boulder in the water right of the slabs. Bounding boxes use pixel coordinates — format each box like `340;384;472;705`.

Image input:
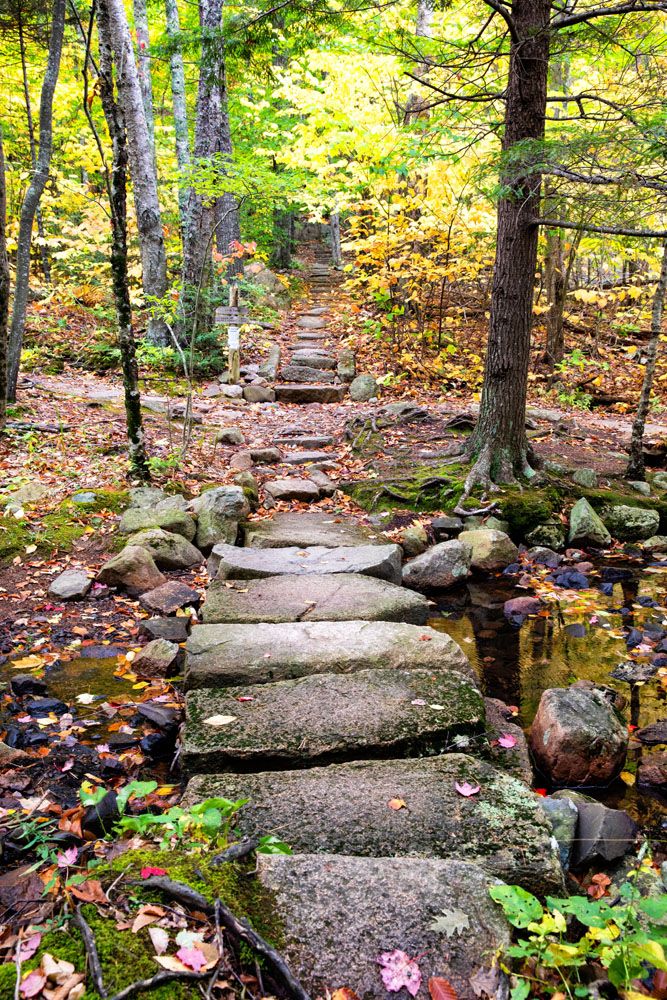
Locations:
530;687;628;785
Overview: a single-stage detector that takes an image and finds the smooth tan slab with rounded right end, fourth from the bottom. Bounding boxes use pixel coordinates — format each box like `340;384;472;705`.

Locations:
185;620;462;689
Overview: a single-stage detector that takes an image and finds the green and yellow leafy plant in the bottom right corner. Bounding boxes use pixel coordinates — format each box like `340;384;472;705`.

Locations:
489;856;667;1000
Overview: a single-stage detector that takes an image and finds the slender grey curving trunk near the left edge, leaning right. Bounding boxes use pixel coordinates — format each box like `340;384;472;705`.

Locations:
7;0;66;402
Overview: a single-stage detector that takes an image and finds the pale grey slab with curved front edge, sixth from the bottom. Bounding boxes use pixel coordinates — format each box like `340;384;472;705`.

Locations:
208;543;401;584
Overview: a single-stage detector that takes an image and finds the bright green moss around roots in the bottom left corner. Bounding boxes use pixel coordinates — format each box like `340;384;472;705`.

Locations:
0;906;192;1000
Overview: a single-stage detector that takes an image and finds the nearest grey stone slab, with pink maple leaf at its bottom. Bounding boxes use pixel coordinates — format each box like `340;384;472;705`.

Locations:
253;855;509;1000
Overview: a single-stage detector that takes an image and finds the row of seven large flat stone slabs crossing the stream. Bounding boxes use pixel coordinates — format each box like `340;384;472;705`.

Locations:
182;512;562;1000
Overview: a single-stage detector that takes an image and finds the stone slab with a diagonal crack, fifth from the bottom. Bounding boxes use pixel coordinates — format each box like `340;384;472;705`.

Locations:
200;573;431;624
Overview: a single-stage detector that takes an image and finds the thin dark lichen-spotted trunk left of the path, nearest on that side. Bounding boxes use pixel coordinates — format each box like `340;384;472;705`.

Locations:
97;0;150;482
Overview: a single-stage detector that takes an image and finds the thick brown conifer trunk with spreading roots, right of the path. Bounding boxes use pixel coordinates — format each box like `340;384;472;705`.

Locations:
466;0;551;492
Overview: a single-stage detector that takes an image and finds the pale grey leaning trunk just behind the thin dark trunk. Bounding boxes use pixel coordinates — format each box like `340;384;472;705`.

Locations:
107;0;169;345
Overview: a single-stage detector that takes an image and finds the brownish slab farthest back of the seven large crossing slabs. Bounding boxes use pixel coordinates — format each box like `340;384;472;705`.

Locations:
241;511;387;549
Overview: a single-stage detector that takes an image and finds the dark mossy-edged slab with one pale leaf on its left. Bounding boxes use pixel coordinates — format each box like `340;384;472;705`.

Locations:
181;668;485;774
